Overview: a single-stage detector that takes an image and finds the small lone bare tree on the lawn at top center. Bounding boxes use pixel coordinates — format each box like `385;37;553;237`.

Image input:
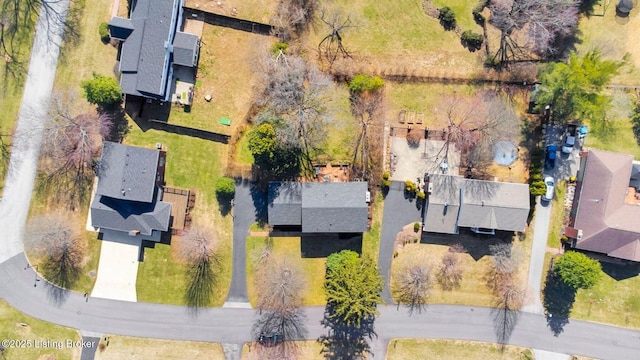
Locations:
318;10;355;68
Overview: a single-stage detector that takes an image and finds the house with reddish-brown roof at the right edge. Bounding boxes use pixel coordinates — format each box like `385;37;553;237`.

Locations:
565;149;640;262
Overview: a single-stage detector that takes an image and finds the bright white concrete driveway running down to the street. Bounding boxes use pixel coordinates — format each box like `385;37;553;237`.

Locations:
91;232;142;302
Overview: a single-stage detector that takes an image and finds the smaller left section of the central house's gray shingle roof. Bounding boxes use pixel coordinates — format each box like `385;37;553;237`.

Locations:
268;182;302;226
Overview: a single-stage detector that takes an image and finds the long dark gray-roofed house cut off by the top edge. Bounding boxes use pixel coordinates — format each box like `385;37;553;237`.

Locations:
109;0;200;101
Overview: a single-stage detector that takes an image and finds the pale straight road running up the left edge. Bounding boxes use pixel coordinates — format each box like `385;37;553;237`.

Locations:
0;0;69;262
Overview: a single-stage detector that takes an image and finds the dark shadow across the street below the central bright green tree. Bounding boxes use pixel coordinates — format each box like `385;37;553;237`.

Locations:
318;305;378;360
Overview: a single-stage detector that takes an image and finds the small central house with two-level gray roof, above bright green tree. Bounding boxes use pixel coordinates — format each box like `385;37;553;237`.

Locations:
268;182;369;233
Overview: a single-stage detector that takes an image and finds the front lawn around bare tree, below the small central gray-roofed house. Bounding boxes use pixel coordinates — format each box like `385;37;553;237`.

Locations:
247;236;326;306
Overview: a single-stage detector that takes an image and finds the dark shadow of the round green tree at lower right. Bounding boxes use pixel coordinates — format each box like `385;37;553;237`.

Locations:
542;271;576;336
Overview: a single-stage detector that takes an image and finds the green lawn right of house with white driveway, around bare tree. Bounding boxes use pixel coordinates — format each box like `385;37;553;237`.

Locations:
125;127;232;306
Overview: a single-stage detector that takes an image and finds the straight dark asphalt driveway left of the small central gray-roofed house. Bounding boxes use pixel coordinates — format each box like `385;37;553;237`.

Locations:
225;180;266;306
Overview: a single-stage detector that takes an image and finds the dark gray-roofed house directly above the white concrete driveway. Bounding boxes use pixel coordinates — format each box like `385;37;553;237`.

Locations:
90;141;171;242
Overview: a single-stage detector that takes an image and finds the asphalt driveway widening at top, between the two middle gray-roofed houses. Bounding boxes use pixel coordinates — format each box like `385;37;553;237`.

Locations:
378;181;420;304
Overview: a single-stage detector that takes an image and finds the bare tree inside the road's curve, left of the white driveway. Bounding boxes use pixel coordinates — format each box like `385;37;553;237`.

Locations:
25;213;86;289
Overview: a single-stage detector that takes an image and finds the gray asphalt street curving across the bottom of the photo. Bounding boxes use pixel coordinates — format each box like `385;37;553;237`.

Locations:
0;254;640;359
